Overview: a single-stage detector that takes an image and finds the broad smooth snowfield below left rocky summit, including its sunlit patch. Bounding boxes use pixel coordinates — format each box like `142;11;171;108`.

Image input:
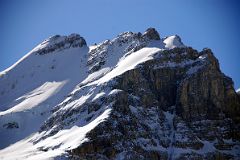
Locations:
0;43;88;149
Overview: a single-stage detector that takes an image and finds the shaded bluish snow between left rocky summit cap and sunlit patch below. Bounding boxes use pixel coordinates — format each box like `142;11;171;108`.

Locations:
0;48;88;111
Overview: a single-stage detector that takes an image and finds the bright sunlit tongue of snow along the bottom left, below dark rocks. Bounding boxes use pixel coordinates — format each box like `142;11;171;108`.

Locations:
0;108;111;160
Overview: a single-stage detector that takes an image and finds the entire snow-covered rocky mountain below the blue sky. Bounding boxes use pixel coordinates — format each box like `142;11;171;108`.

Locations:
0;28;240;160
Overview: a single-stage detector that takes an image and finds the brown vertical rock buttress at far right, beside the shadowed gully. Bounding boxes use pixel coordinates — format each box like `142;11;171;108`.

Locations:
177;49;240;122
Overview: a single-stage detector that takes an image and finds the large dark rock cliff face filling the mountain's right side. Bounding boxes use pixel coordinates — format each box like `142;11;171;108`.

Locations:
70;47;240;159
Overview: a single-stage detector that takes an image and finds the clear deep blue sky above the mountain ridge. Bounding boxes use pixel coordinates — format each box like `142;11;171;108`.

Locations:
0;0;240;88
